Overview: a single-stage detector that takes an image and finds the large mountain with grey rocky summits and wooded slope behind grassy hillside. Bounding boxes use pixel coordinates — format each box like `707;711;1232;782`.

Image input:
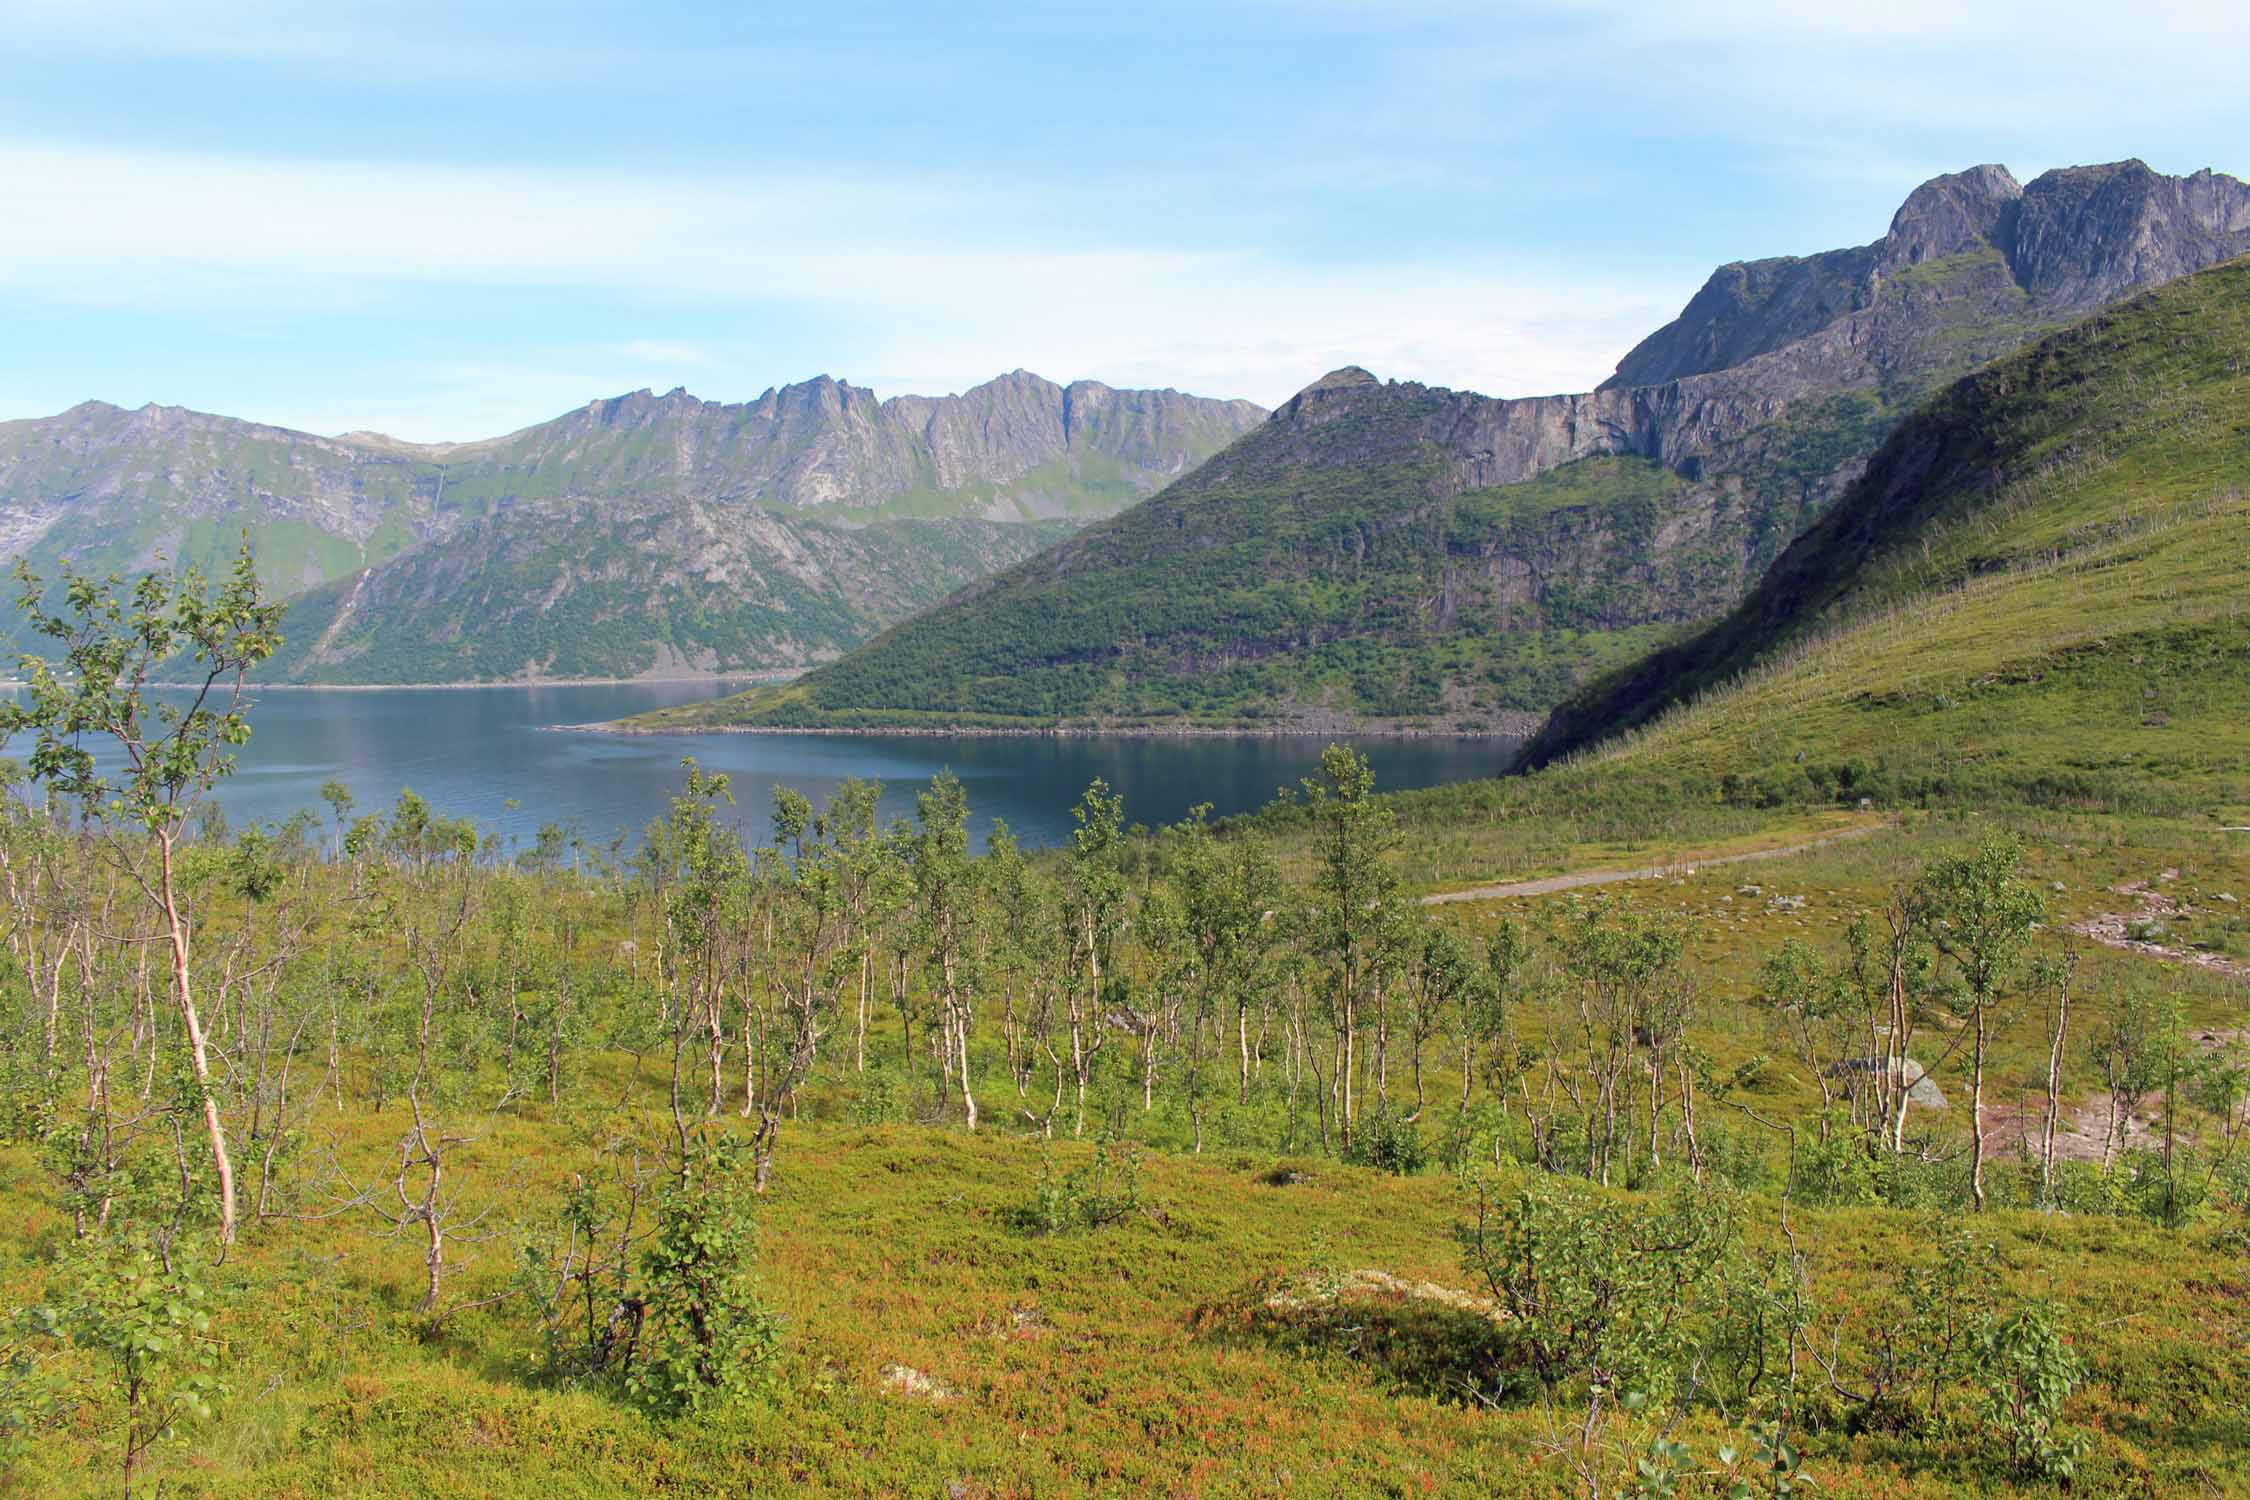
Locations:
646;162;2250;731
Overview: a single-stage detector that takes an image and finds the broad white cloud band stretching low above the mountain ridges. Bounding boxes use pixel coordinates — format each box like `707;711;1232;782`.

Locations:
0;142;1679;439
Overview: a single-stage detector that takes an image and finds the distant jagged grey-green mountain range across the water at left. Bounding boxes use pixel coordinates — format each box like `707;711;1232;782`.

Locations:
0;371;1265;681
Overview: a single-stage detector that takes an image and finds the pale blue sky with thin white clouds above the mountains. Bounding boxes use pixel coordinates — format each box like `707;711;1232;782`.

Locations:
0;0;2250;439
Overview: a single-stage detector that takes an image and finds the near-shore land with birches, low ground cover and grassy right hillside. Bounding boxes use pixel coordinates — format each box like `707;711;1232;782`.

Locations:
0;268;2250;1500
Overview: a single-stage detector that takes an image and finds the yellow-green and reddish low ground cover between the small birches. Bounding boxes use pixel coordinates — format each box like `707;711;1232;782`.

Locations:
0;791;2250;1500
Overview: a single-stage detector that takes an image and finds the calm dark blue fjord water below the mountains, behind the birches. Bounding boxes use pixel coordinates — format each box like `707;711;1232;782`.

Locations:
7;684;1514;848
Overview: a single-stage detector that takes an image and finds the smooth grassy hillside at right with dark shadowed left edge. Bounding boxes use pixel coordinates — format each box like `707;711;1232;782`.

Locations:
1528;261;2250;821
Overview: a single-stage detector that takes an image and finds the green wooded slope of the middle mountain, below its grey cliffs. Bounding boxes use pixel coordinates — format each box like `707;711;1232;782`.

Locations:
616;393;1883;733
